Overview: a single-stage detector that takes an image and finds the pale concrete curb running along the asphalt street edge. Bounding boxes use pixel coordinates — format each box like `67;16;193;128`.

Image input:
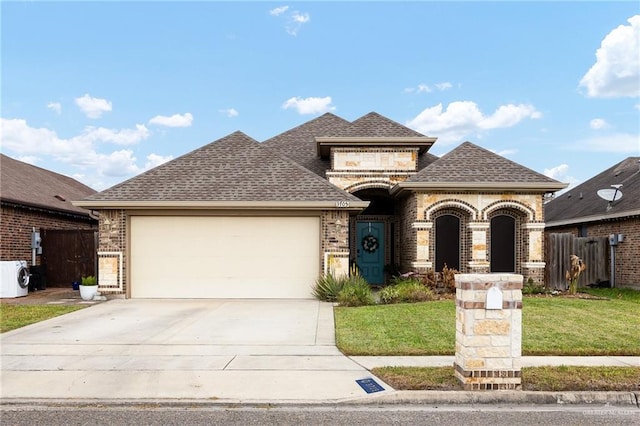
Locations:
0;391;640;409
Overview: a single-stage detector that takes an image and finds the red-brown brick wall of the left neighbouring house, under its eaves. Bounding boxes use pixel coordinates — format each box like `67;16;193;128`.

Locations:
0;205;98;265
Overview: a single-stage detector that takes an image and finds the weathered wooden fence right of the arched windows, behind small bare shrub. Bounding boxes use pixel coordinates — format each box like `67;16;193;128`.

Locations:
545;233;610;290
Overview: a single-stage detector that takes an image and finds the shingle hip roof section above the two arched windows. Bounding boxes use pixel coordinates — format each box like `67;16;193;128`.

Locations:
407;142;559;185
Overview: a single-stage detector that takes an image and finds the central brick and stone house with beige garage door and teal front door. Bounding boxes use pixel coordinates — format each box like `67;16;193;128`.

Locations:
76;113;566;298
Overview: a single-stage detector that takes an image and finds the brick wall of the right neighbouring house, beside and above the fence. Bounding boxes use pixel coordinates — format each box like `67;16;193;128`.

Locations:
545;216;640;286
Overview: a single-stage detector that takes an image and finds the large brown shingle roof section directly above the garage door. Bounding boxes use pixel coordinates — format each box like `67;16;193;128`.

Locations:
76;132;368;210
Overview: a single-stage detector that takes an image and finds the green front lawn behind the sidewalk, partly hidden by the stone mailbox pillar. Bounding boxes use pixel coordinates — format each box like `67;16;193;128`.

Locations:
335;289;640;355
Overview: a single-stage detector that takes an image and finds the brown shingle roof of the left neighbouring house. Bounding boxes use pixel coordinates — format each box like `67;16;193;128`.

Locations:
0;154;96;218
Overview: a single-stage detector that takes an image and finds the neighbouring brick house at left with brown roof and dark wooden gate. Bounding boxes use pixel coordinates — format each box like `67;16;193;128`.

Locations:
0;154;98;285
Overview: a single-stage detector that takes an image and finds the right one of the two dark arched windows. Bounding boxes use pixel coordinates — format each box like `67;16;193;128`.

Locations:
491;215;516;272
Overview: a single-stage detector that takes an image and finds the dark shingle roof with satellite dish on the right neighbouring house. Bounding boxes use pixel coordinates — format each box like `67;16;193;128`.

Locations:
545;157;640;226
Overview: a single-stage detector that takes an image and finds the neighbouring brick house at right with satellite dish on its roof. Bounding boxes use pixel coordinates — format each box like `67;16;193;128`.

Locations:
545;157;640;286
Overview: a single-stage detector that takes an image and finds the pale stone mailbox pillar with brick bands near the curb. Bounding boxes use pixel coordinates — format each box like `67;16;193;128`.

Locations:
454;274;523;390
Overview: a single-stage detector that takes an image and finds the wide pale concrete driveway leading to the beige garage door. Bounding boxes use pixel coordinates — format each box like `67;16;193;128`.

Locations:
0;299;392;402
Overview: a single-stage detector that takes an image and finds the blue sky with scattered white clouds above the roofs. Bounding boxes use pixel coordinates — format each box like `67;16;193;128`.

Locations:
0;1;640;190
